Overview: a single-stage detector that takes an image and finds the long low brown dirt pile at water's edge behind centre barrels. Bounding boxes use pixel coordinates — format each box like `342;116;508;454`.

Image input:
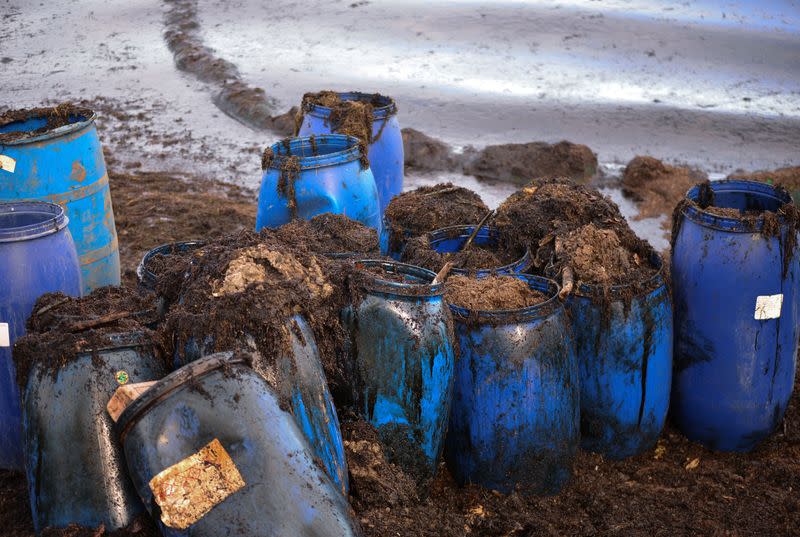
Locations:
464;141;597;184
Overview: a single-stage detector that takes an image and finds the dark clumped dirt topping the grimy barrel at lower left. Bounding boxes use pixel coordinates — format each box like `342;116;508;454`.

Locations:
14;287;164;388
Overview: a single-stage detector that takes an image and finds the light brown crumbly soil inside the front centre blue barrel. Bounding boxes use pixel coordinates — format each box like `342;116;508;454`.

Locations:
445;275;549;311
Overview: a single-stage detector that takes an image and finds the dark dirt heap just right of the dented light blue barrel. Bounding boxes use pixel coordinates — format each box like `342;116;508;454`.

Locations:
385;183;489;250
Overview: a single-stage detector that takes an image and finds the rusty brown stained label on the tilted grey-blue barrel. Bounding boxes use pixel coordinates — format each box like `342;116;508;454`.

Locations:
150;438;245;530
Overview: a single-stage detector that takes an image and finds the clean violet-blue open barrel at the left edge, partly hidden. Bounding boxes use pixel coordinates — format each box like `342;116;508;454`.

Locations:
0;202;81;470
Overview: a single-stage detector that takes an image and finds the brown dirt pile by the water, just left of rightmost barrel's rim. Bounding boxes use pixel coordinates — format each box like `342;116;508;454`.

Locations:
622;156;707;219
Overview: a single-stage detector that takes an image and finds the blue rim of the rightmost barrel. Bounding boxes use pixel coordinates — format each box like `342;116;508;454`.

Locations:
682;179;792;233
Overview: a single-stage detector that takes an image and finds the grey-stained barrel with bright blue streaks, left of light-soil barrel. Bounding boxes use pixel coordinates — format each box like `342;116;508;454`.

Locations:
343;260;455;483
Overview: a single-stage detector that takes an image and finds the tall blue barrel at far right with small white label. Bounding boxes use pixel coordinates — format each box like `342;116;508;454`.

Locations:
671;181;800;452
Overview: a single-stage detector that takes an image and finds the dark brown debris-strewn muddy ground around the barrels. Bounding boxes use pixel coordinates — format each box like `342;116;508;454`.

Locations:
0;163;800;537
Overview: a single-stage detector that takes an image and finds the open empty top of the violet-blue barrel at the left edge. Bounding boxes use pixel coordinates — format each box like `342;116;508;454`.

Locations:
0;201;69;243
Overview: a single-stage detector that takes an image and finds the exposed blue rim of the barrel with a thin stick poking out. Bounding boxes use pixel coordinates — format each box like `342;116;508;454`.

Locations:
429;226;531;278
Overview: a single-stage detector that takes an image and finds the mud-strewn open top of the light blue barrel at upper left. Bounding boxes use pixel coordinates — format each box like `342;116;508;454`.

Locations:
0;103;95;145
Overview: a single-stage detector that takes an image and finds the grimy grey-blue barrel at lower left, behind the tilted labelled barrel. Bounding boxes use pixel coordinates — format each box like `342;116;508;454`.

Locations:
22;333;166;533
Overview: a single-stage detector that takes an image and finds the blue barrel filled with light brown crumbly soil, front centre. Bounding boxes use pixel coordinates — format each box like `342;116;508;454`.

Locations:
445;274;580;494
